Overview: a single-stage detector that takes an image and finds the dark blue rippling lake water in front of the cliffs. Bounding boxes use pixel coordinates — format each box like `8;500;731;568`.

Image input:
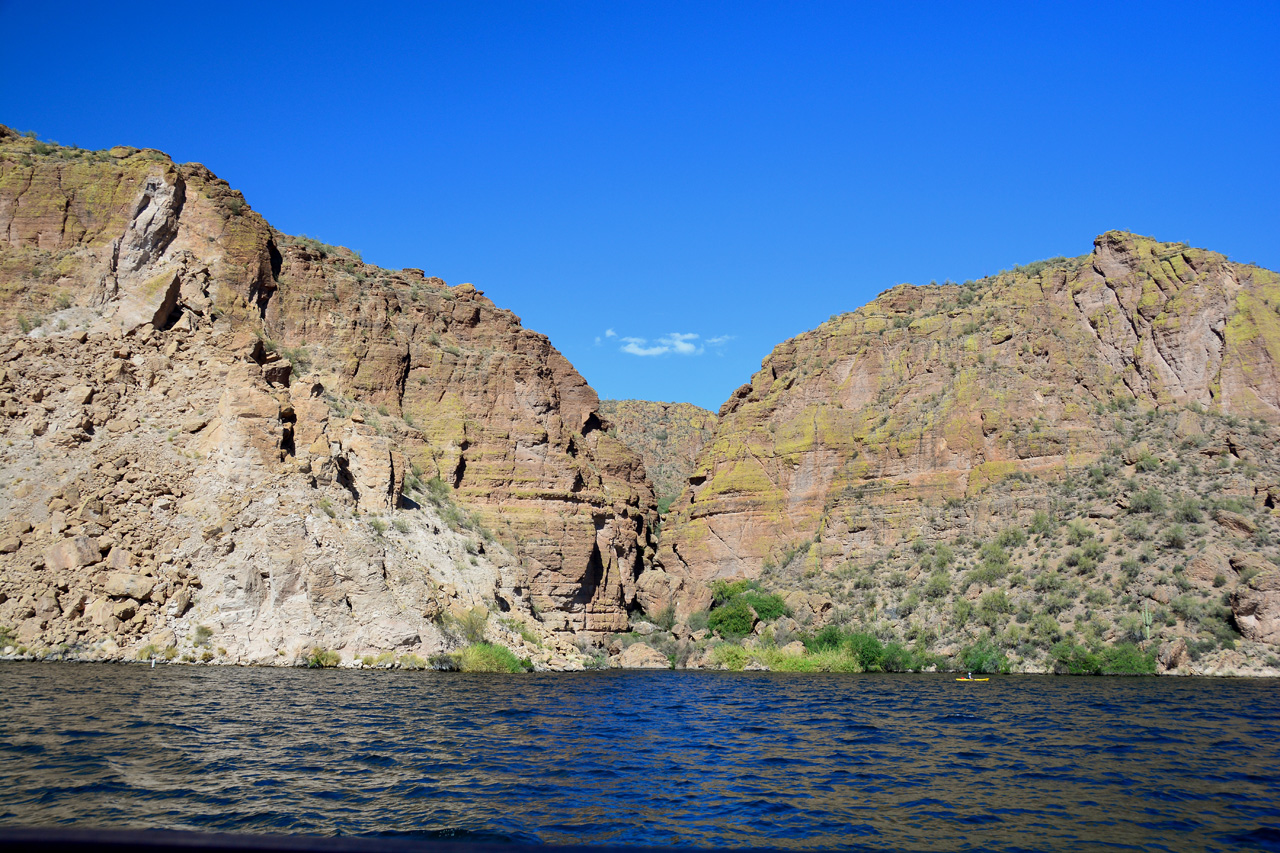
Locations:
0;663;1280;850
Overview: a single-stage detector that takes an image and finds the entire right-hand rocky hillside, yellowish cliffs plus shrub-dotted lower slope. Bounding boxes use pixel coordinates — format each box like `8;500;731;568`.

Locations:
646;232;1280;671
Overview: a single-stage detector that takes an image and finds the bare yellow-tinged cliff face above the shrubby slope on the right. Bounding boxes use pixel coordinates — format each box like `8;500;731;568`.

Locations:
660;232;1280;580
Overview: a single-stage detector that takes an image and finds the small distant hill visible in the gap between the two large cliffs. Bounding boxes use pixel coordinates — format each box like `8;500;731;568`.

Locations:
600;400;716;511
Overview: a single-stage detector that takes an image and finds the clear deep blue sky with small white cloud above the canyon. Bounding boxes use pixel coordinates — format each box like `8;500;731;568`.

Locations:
0;0;1280;409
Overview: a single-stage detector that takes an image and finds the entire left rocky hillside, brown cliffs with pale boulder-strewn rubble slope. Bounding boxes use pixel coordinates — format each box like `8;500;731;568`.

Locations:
0;128;657;665
